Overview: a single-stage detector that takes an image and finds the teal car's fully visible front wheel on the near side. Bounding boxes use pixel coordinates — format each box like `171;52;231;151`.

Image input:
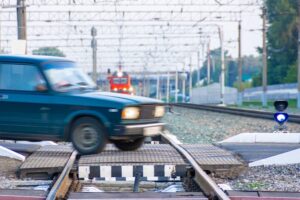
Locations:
71;117;107;155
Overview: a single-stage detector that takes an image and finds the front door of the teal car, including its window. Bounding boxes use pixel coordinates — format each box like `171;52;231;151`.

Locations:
0;63;52;140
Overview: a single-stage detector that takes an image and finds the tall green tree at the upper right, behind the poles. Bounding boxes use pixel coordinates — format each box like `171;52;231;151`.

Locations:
266;0;298;84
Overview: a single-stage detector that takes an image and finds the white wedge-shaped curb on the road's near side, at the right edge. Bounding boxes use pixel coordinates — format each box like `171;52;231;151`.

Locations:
249;149;300;167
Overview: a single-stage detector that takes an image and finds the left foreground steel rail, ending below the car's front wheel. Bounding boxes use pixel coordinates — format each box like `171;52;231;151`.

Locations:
46;151;77;200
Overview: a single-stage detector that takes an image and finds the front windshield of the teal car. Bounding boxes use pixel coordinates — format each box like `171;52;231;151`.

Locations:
44;62;96;91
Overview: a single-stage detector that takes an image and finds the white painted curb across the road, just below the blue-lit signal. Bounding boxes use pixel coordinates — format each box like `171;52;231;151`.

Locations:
218;133;300;144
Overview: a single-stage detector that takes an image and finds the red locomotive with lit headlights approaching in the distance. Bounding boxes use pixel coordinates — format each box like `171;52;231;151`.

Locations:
108;67;133;95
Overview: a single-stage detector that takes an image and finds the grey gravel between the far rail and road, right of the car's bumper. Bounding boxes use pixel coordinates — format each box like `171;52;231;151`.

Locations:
164;107;300;144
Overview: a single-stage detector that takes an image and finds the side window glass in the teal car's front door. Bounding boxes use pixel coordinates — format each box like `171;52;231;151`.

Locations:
0;63;45;91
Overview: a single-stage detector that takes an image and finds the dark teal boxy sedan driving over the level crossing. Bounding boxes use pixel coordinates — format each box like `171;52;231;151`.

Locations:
0;55;165;154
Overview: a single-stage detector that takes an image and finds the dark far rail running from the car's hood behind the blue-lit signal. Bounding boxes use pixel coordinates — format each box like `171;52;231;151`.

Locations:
170;103;300;123
